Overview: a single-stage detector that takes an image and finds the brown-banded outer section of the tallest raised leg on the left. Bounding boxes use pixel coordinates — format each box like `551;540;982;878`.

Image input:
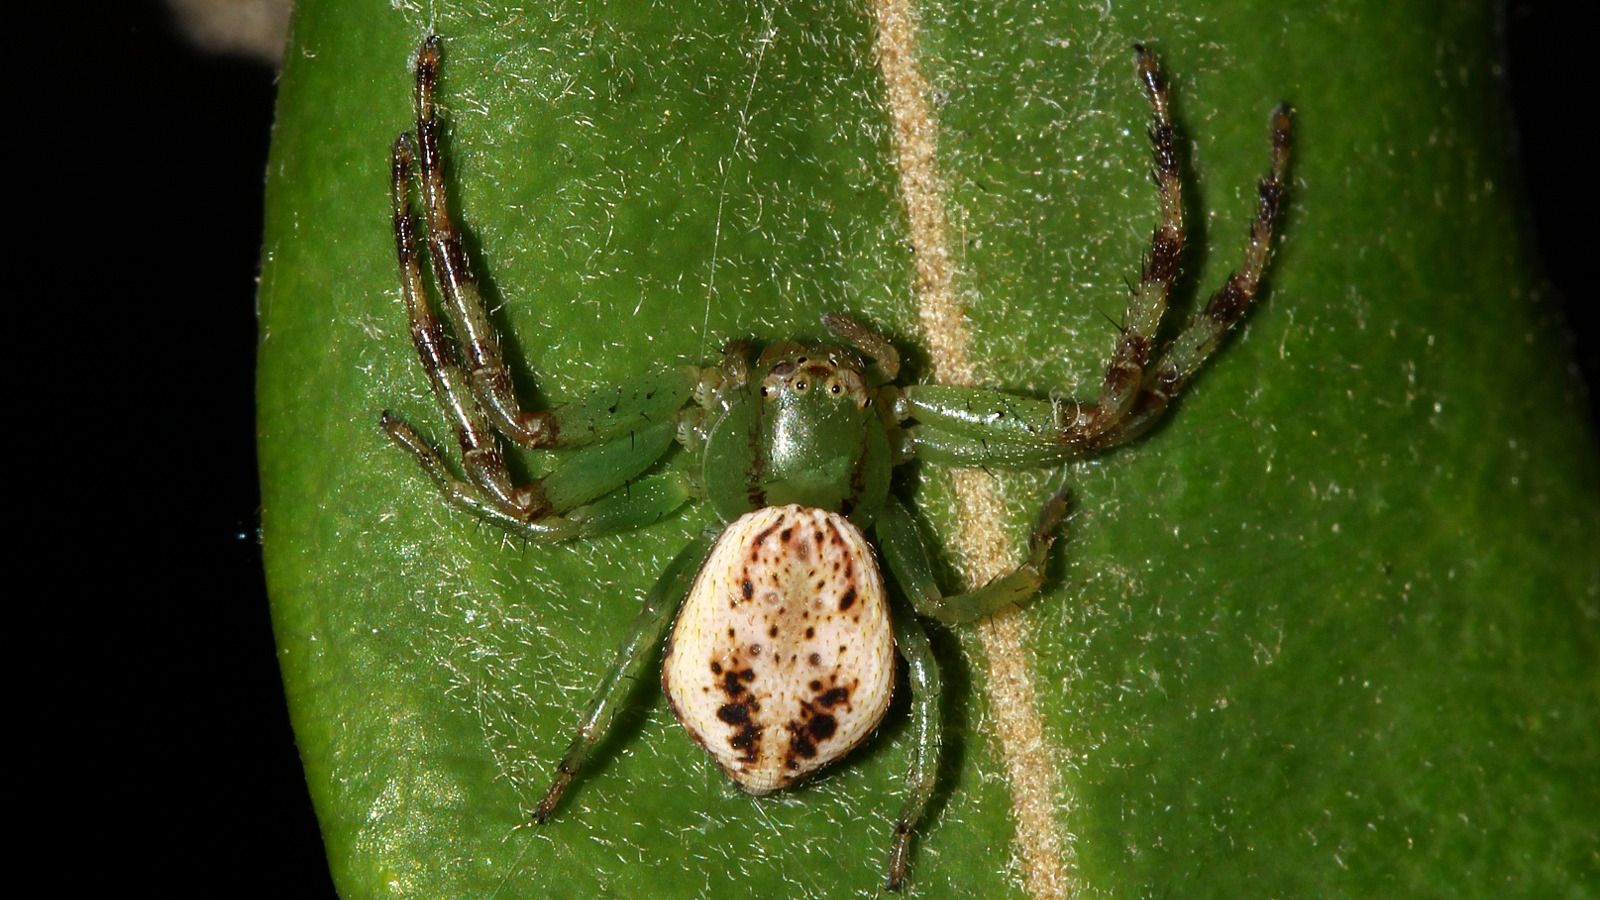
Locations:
416;35;558;448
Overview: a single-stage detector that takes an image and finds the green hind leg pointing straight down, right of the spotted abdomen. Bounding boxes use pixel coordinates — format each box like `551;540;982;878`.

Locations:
883;604;944;890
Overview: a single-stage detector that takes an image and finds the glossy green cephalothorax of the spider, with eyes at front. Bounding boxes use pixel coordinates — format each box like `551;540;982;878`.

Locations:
704;341;890;528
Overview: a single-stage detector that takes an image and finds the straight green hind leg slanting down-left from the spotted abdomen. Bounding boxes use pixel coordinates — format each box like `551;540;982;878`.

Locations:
533;533;715;825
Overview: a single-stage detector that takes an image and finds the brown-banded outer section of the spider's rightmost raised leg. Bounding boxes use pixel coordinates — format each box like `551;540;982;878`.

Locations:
1096;104;1294;447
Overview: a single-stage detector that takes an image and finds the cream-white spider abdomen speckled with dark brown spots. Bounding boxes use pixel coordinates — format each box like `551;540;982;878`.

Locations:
661;506;894;794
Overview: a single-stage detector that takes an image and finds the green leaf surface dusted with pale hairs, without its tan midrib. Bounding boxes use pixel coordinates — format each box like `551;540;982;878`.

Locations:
259;0;1600;897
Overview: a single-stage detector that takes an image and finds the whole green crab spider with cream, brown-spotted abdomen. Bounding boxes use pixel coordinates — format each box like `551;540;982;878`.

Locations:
381;37;1291;890
